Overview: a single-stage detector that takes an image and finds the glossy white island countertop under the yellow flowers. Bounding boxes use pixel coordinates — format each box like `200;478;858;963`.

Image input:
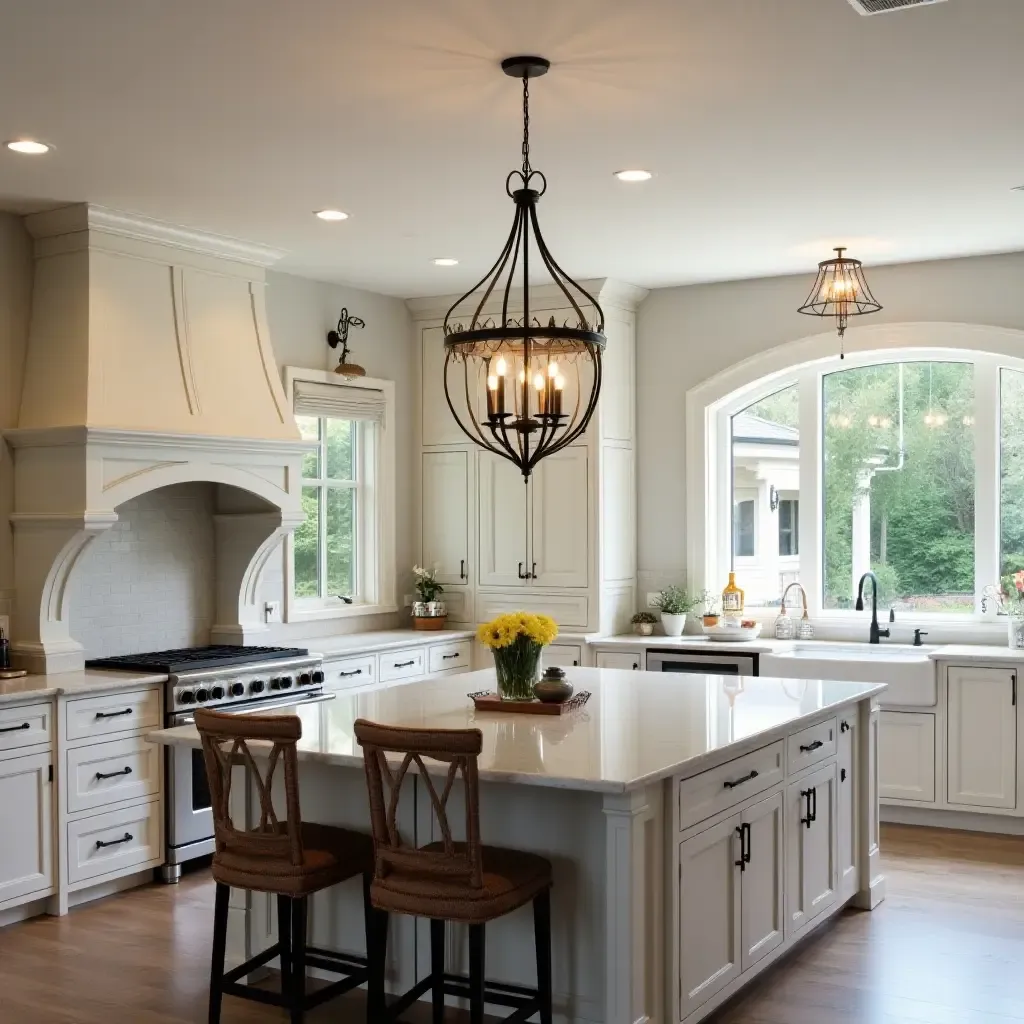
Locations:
148;669;886;793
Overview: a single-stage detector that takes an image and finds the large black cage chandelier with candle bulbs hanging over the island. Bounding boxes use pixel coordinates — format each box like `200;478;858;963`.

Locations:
444;56;605;479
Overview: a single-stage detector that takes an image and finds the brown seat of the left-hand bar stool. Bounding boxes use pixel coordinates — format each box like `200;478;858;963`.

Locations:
213;821;374;897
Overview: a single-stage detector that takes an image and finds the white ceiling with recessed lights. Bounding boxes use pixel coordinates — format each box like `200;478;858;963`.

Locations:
0;0;1024;296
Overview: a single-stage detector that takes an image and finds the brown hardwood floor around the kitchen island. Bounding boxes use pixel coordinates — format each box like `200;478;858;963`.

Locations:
0;825;1024;1024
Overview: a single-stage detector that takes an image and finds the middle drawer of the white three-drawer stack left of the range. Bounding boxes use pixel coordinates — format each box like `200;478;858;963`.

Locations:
65;736;163;814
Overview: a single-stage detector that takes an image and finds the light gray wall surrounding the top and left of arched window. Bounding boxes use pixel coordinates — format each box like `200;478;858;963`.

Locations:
637;253;1024;595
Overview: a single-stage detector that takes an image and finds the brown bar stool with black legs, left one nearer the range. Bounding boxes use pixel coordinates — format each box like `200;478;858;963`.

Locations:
196;710;374;1024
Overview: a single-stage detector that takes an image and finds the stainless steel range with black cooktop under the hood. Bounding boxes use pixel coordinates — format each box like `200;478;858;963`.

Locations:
86;646;331;882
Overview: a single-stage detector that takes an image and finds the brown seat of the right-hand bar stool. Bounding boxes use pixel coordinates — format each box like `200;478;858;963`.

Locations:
370;842;552;925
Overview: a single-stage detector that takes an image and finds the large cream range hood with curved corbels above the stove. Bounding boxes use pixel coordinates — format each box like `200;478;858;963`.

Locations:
4;205;305;672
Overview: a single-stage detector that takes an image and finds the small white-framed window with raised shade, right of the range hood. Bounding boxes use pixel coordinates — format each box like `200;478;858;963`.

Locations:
286;369;395;620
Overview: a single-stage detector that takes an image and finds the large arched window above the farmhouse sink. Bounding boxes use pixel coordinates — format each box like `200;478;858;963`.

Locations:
687;325;1024;623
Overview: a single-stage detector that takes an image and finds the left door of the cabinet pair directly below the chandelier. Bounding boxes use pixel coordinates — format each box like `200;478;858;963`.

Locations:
476;452;529;587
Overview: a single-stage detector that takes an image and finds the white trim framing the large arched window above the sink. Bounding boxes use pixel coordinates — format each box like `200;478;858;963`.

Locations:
685;323;1024;642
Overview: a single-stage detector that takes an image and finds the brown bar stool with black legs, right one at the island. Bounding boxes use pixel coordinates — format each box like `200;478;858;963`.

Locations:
355;719;552;1024
